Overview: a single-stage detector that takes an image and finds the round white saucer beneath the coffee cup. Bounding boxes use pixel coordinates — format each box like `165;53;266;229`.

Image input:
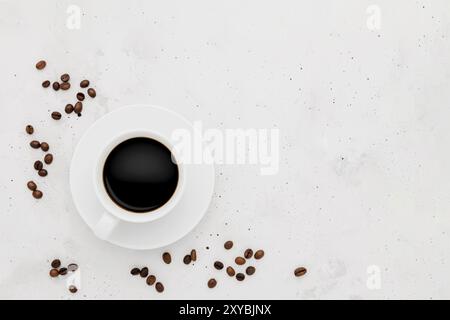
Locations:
70;105;214;250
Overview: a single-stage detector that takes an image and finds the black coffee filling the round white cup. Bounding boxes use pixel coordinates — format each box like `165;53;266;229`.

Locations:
103;138;178;212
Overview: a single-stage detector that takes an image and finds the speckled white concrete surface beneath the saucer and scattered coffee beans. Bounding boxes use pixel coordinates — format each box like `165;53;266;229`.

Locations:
0;0;450;299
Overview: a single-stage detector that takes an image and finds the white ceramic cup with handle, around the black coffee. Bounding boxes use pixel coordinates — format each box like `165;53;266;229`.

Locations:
93;129;185;240
